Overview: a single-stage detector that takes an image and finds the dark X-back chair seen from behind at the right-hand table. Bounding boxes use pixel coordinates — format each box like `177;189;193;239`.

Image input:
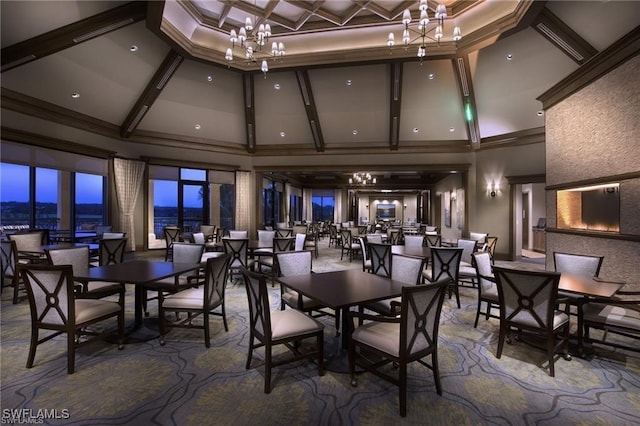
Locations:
493;266;571;377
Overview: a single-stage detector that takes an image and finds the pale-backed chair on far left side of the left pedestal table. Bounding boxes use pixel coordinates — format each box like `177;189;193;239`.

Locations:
45;246;126;307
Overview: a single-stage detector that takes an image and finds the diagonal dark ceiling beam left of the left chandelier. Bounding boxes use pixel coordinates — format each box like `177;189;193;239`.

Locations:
120;50;184;138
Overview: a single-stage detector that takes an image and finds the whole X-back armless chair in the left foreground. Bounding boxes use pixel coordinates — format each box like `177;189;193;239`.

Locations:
18;264;124;374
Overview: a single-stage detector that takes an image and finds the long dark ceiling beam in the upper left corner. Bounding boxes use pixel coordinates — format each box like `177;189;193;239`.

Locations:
0;1;147;72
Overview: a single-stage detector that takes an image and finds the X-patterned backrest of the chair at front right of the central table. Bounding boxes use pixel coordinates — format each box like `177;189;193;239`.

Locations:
400;279;449;359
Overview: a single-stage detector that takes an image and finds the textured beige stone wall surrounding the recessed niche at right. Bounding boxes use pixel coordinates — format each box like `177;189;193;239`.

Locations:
545;57;640;290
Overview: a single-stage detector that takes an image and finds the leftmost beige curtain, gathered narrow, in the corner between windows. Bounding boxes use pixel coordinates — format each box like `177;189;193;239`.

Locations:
113;158;145;251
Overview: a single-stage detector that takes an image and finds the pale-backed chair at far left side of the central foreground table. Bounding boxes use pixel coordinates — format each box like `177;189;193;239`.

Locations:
276;250;340;336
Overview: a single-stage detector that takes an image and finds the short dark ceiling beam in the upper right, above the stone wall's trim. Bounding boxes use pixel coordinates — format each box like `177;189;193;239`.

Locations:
531;8;598;65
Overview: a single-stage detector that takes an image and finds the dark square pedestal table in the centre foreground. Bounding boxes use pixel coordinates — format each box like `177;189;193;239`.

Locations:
278;269;407;372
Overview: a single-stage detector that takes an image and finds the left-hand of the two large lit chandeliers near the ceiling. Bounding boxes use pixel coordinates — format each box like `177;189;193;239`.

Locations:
224;17;286;78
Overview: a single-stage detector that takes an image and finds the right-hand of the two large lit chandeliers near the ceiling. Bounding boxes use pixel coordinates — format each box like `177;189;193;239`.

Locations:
387;0;462;62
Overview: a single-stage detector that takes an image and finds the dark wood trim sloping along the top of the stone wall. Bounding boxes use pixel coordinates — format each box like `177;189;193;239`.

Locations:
537;26;640;110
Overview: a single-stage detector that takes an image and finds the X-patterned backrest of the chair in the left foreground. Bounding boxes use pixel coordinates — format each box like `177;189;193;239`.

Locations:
18;264;76;328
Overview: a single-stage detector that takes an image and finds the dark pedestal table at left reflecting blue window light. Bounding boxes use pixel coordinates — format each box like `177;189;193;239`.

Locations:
74;260;201;343
